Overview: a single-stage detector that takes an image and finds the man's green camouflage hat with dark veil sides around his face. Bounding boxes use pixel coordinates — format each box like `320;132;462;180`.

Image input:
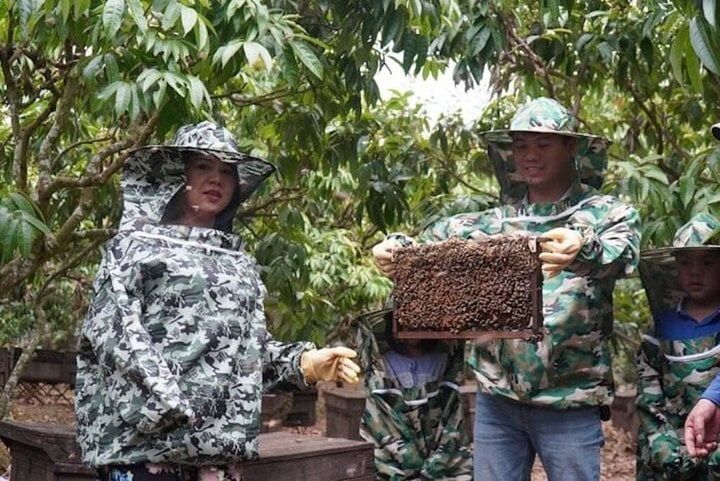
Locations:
480;97;610;204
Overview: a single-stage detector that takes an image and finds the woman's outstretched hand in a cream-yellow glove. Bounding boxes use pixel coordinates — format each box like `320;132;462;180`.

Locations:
300;347;360;384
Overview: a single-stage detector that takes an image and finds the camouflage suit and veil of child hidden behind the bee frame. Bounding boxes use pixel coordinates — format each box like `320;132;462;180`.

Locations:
353;312;473;481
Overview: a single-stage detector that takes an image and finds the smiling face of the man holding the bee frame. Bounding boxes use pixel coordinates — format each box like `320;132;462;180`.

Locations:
511;132;576;195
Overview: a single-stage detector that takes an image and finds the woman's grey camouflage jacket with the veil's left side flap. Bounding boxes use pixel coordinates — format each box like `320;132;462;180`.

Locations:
76;145;314;467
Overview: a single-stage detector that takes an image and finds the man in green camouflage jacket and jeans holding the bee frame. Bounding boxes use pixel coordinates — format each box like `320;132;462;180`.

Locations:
373;98;640;481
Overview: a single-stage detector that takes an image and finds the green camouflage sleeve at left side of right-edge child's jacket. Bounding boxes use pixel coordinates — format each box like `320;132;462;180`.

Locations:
636;335;691;472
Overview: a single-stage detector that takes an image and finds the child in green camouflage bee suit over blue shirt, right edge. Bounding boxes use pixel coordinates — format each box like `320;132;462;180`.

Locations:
637;213;720;481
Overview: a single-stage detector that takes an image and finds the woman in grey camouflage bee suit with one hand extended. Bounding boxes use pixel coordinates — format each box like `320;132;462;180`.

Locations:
76;122;359;481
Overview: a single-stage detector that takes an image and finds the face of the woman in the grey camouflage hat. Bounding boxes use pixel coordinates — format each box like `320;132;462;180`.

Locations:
183;154;237;227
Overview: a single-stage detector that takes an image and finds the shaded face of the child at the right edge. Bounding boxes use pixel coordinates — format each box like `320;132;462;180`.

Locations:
675;250;720;304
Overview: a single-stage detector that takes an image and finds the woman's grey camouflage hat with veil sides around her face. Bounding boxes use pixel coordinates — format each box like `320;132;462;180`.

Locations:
120;121;275;231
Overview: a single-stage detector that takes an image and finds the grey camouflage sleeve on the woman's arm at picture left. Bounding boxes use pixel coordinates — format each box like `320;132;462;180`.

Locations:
82;242;193;433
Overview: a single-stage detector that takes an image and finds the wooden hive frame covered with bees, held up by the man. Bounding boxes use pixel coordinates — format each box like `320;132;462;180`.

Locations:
393;235;542;340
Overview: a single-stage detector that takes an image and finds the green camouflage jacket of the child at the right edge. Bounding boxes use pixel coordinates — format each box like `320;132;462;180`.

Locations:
637;326;720;481
